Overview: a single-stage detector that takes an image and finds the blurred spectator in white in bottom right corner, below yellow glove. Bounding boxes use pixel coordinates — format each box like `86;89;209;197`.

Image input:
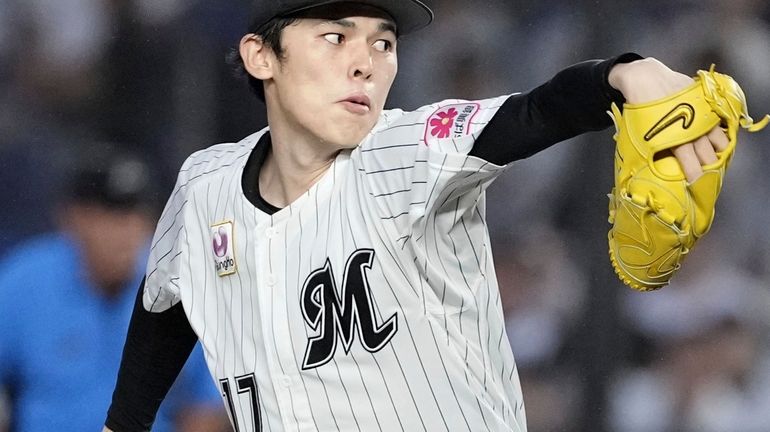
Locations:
610;232;770;432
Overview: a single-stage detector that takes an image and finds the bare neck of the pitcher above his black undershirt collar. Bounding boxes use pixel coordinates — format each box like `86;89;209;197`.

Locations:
259;121;340;208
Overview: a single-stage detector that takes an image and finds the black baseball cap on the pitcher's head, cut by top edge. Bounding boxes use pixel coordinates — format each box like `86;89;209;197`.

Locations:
252;0;433;35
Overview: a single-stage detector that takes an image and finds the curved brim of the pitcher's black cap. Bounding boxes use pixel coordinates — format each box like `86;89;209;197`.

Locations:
283;0;433;35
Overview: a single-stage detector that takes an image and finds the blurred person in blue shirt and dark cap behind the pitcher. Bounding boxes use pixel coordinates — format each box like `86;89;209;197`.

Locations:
0;152;228;432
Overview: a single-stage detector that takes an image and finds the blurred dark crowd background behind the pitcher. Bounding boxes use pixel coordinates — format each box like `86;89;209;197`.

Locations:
0;0;770;432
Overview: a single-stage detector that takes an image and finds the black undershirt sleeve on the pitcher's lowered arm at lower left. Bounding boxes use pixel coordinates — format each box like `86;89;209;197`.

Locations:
105;281;198;432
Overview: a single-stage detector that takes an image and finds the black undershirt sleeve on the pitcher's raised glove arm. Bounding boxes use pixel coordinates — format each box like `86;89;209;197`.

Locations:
469;53;642;165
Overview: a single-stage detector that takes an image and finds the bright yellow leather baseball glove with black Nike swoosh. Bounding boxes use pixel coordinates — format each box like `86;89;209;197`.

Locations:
608;66;770;291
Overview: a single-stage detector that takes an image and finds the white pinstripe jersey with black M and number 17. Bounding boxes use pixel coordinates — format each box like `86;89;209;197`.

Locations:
144;97;526;432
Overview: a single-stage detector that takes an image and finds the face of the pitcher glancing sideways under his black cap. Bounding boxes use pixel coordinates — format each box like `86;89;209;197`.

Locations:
265;10;398;148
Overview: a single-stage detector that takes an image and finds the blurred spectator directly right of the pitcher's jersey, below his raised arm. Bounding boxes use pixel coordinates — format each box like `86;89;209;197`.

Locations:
495;224;587;432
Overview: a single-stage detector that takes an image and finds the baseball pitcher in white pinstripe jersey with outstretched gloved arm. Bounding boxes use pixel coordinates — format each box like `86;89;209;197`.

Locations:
106;0;768;432
